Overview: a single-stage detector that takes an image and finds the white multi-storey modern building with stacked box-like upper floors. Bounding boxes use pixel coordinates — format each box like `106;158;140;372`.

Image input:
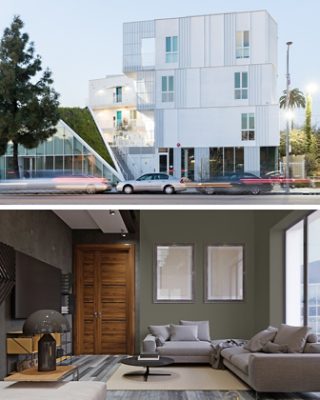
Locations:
89;11;280;179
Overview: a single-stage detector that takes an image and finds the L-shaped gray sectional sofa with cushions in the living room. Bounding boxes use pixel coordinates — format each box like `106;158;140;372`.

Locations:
142;321;320;392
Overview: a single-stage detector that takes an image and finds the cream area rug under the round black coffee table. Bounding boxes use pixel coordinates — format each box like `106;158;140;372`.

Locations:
107;364;249;390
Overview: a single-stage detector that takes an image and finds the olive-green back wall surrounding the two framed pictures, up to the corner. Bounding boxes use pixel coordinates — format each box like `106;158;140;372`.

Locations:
139;211;255;338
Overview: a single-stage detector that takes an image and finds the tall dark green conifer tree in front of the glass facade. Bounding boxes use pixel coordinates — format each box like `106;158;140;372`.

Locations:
0;16;59;177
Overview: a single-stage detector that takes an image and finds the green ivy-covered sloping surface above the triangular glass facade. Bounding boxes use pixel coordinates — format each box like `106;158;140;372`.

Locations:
59;107;113;166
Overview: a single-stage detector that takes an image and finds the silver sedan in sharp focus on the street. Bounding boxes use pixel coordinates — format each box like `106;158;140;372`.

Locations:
117;173;186;194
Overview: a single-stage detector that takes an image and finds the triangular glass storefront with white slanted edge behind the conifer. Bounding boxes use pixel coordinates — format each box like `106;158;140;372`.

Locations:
0;122;119;182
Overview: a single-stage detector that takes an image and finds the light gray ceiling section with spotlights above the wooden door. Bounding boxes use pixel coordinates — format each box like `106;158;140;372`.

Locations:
53;210;128;233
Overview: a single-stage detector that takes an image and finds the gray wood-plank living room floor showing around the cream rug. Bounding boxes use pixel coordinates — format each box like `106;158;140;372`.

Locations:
66;356;320;400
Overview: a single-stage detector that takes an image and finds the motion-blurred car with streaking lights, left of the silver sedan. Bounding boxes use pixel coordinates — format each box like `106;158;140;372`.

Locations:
0;175;112;194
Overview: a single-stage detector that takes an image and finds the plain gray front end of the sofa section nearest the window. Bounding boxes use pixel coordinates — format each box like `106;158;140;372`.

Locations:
248;353;320;392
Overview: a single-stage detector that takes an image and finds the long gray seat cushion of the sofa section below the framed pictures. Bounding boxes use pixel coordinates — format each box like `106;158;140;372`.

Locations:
158;341;212;356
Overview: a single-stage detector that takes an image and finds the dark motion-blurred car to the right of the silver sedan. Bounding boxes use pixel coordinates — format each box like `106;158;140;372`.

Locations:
198;172;272;195
